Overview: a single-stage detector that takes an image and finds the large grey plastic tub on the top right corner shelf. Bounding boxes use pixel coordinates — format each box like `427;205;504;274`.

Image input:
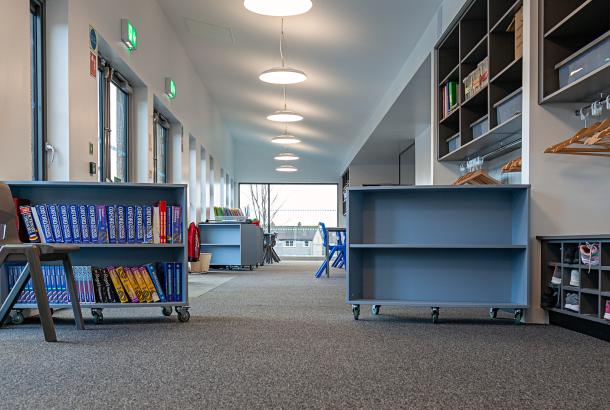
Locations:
555;37;610;88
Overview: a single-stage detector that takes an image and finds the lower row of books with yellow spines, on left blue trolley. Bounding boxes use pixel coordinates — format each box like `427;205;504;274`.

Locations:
7;262;183;305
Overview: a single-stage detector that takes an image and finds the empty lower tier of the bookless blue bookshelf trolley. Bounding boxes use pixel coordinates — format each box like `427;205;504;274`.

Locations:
347;248;528;308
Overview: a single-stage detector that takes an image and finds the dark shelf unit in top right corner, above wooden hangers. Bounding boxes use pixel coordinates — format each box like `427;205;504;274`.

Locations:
539;0;610;104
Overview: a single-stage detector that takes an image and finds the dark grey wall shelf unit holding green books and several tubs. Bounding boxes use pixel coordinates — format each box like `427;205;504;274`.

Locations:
435;0;523;161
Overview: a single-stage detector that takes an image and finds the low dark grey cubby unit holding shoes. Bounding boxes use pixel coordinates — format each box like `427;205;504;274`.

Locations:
538;235;610;340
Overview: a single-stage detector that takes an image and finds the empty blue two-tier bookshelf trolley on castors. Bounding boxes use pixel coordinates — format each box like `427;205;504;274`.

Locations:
346;185;529;323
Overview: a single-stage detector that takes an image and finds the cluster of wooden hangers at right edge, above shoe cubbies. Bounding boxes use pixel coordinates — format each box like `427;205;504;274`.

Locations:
544;117;610;157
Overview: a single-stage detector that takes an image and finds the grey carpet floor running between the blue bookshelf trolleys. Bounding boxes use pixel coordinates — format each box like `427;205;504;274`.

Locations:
0;262;610;409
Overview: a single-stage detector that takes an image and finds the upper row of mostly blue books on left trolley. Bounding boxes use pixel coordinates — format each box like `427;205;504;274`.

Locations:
14;198;183;244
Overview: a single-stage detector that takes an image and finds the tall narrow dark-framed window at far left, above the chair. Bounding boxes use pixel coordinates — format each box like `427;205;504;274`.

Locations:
30;0;46;181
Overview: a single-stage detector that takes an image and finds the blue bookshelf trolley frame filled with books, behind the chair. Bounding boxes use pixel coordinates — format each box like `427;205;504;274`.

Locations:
0;182;190;323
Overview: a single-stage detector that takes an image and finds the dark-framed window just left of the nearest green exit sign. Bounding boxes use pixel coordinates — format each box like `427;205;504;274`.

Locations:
98;59;131;182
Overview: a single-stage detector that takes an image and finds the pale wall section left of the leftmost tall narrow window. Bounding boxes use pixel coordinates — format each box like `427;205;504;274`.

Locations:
0;0;32;180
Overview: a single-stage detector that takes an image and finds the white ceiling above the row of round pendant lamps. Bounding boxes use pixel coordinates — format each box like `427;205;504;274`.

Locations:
158;0;441;173
